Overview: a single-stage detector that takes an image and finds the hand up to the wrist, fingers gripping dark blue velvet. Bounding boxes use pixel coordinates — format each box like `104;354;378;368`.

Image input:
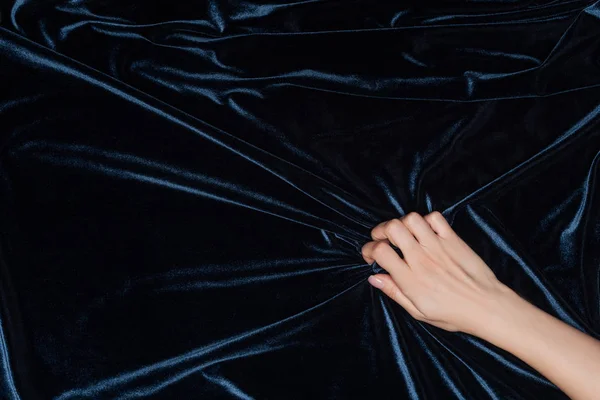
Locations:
362;212;516;334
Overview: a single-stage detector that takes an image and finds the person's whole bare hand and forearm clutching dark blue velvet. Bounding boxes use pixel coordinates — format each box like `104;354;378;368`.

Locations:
362;212;600;400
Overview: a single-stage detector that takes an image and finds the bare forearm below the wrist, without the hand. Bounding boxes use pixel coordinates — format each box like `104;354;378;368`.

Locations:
474;291;600;400
